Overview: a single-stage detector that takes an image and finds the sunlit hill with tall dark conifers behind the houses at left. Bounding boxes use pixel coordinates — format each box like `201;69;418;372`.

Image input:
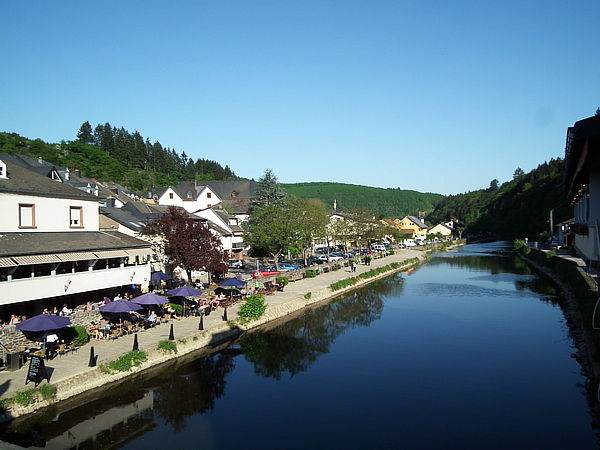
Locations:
0;122;236;192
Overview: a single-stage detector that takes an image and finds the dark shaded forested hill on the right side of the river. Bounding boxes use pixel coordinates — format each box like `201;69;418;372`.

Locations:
426;158;573;235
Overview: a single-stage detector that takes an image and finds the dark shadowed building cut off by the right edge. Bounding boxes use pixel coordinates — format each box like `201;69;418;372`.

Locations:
563;115;600;263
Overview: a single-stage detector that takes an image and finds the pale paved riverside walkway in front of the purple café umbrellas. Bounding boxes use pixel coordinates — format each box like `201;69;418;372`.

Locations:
0;249;425;399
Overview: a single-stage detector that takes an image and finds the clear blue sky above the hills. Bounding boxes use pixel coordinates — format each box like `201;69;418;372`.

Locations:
0;0;600;195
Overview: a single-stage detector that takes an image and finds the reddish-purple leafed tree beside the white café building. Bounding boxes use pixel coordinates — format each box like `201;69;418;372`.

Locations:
142;206;227;283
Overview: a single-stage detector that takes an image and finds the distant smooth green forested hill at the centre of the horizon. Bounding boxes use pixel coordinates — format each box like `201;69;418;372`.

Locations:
281;183;444;219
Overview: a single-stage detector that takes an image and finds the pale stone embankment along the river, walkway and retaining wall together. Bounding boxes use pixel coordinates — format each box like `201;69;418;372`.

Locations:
0;249;448;420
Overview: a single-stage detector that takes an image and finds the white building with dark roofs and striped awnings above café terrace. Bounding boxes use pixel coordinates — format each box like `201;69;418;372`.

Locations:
0;159;152;320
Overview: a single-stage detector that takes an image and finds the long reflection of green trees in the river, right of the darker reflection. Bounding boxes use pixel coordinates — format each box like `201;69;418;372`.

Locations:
240;277;404;380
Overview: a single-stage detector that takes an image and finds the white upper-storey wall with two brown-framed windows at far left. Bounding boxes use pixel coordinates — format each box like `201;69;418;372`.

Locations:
0;193;99;233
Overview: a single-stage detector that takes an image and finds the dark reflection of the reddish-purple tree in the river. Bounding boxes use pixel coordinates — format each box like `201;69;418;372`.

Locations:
154;352;235;433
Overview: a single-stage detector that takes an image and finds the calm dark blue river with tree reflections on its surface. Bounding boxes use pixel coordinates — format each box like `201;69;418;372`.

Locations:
2;243;598;450
